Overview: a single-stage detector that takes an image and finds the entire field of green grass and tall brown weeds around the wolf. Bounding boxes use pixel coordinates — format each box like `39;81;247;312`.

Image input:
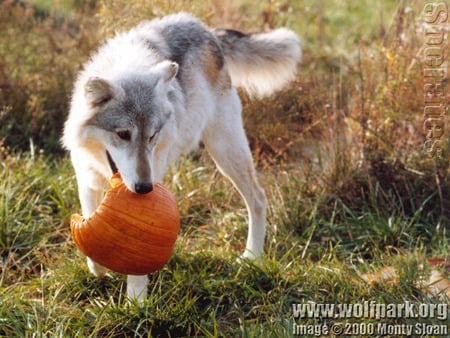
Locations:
0;0;450;337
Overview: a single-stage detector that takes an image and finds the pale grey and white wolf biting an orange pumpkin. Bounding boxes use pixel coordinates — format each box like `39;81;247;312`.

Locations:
62;13;301;301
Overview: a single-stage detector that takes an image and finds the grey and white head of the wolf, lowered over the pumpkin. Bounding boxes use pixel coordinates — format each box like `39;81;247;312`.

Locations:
84;61;178;194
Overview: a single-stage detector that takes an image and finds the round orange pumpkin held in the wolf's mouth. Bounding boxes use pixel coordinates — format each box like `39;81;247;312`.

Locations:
70;174;180;275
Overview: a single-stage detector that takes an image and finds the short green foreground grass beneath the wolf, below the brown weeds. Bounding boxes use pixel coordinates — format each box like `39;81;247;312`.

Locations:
0;153;448;337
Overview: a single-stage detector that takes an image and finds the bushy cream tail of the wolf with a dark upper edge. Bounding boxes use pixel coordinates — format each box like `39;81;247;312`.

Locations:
214;28;302;96
